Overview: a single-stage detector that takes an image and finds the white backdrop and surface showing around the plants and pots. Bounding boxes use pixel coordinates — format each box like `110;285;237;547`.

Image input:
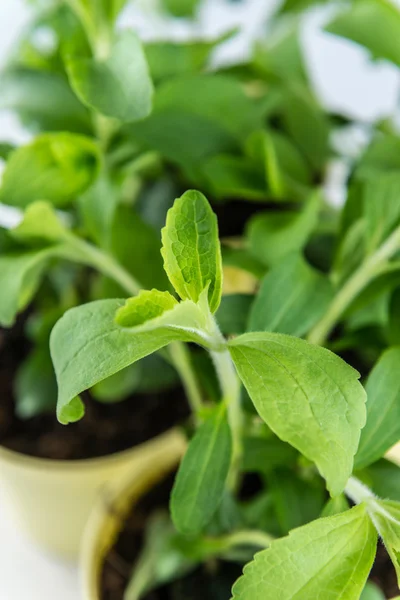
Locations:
0;0;400;600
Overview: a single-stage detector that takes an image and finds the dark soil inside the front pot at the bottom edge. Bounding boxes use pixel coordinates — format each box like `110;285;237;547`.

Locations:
100;476;242;600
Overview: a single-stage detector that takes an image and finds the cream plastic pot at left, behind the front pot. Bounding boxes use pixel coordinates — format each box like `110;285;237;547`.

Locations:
0;429;183;559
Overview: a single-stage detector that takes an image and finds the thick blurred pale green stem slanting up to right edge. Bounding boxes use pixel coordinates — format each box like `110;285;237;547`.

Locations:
308;227;400;346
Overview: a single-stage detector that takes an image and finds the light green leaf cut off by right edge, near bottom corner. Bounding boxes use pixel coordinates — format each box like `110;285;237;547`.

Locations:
369;500;400;587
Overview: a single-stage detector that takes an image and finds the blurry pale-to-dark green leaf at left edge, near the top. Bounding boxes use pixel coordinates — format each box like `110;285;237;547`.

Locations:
0;67;92;133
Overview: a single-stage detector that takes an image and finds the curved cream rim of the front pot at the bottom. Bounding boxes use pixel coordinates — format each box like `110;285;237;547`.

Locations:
81;433;186;600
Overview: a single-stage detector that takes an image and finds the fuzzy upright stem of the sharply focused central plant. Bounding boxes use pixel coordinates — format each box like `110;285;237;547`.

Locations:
211;349;243;491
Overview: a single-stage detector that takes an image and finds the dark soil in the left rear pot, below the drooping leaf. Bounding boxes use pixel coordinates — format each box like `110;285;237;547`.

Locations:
0;317;189;460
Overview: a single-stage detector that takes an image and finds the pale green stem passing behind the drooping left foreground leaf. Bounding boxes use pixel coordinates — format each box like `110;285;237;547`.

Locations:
68;235;202;415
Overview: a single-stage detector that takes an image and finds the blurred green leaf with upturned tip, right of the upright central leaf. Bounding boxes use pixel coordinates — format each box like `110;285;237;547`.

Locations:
246;194;320;267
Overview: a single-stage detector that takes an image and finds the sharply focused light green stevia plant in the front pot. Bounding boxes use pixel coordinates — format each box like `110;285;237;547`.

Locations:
51;191;400;600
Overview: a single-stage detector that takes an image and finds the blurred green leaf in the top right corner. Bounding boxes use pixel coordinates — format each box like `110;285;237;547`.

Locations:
325;0;400;66
